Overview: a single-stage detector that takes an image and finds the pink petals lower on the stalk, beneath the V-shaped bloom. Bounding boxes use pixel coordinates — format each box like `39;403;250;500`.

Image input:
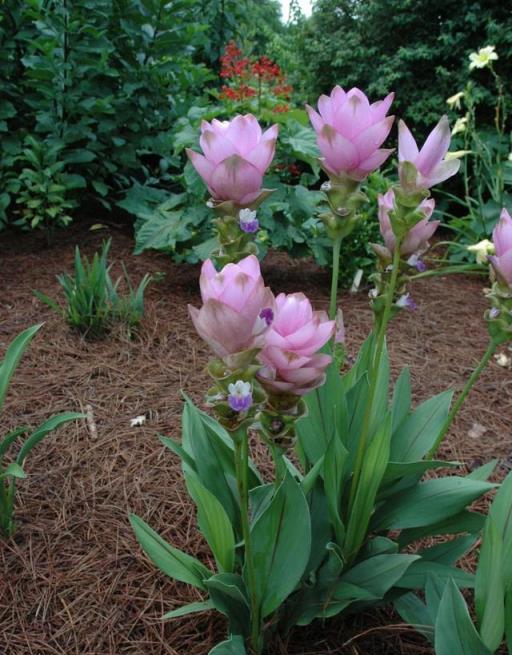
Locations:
377;189;440;257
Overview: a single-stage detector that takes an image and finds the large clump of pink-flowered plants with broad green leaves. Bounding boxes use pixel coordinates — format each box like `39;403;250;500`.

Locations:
131;86;512;655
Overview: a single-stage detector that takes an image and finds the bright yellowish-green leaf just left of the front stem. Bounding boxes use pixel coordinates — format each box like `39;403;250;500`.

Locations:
185;471;235;572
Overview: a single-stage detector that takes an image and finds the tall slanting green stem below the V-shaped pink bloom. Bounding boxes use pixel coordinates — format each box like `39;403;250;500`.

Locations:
349;240;400;513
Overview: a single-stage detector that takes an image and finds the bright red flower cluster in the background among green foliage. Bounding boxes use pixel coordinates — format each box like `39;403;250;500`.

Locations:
219;41;293;113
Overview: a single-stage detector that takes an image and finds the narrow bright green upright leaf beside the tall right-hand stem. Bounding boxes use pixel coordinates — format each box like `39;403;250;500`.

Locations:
343;412;391;561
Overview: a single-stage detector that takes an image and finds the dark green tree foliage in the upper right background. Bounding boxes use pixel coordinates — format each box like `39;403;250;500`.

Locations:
291;0;512;132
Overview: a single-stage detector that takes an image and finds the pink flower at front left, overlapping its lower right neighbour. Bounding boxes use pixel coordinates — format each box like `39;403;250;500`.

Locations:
188;255;274;357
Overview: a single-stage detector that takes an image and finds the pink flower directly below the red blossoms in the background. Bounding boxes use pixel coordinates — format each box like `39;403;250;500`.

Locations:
187;114;279;205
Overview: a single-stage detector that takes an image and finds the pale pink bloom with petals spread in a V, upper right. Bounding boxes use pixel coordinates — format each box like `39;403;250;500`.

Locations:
398;116;460;189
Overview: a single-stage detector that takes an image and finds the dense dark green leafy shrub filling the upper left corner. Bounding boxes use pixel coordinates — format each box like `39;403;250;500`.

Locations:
0;0;209;227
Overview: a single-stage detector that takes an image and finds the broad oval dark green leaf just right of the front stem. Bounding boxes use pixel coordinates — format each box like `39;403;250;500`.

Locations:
249;473;311;618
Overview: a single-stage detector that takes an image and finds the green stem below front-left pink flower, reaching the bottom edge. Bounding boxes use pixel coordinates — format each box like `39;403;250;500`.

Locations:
234;429;261;655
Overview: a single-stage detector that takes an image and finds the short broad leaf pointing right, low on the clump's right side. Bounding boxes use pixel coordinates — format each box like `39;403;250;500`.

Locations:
336;553;418;598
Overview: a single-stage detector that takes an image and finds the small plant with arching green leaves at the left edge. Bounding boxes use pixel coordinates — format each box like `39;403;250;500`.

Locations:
0;324;83;537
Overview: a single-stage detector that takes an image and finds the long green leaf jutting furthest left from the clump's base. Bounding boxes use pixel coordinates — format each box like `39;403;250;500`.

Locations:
130;514;212;591
